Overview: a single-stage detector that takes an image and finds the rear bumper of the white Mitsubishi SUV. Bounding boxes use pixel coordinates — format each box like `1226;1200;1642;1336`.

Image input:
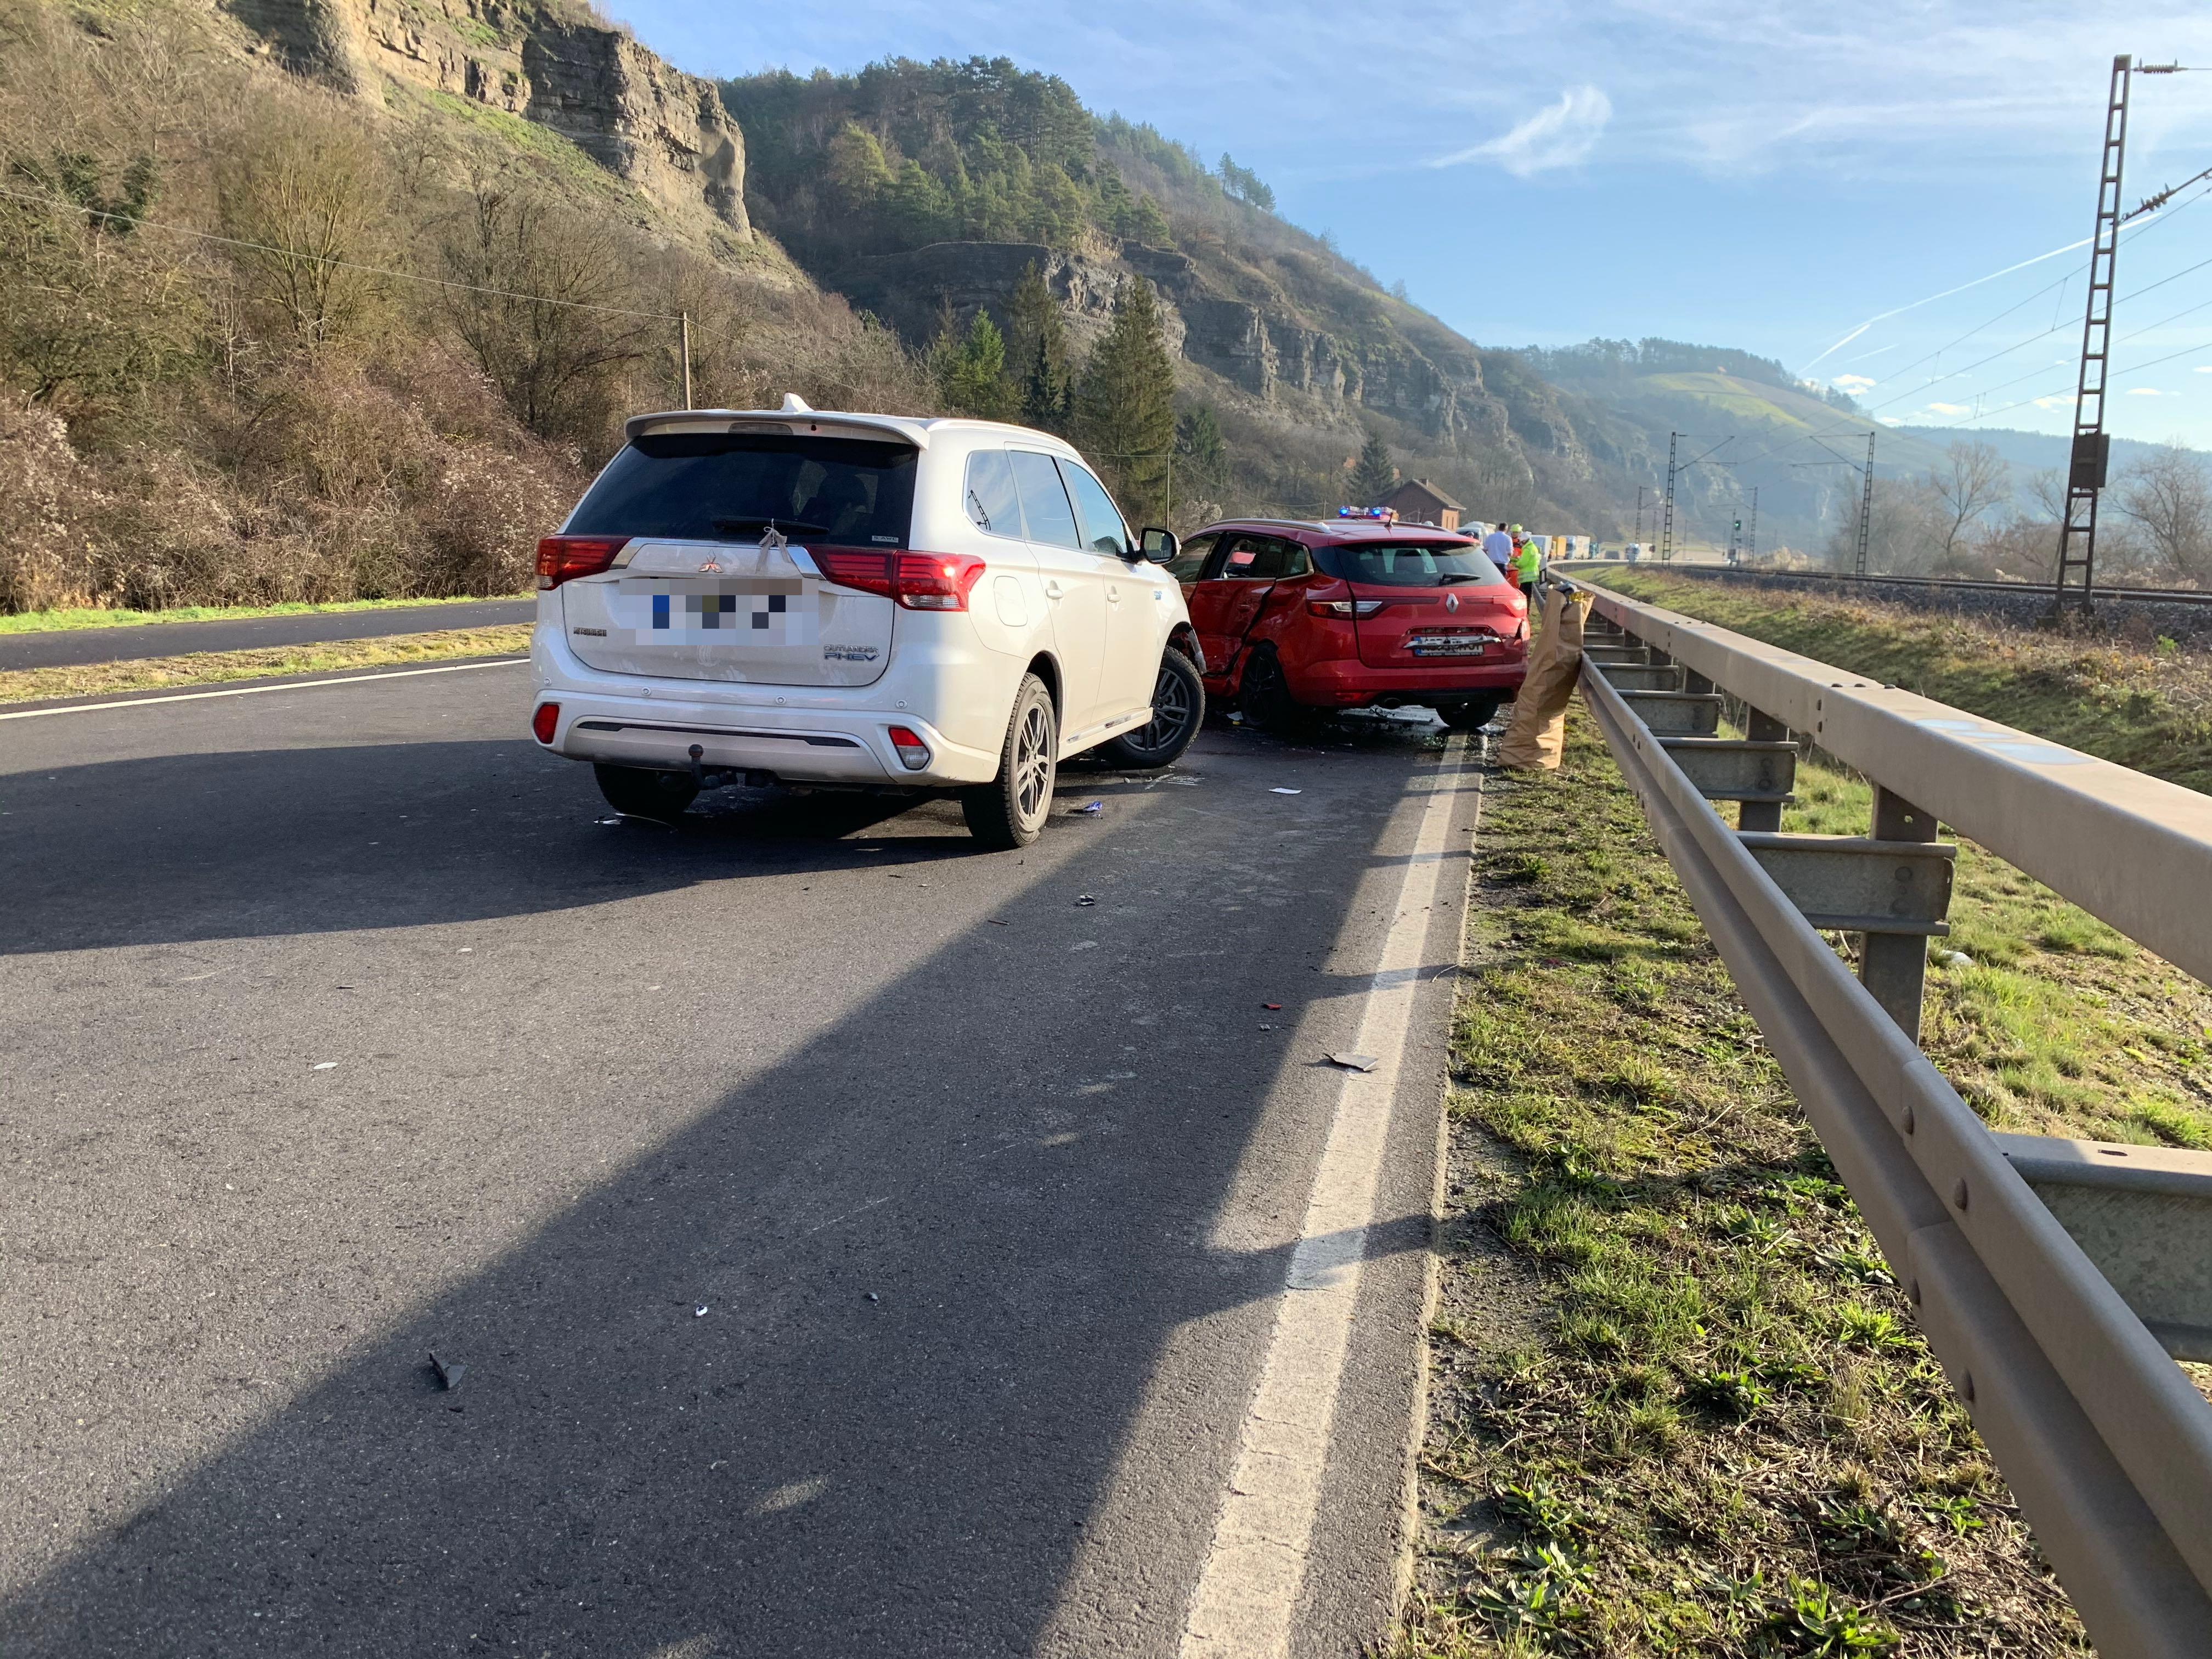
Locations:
531;624;1011;787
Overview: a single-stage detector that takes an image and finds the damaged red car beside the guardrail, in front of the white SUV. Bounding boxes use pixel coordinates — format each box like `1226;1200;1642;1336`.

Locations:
1168;517;1528;732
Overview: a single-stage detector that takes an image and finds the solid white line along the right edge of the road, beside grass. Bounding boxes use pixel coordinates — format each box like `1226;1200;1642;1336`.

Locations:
1181;737;1466;1659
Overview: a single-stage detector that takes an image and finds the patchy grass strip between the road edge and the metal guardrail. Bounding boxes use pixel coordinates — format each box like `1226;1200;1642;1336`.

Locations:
1389;708;2086;1659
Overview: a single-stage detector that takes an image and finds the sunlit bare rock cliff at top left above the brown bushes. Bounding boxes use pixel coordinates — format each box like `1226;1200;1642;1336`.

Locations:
221;0;752;241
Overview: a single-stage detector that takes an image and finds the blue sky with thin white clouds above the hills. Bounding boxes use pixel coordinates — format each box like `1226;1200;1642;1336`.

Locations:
617;0;2212;447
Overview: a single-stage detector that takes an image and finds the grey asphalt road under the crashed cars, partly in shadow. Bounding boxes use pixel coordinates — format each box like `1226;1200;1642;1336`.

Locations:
0;666;1480;1659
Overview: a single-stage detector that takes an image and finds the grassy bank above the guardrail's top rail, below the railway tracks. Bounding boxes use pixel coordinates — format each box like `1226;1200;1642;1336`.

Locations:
1577;571;2212;792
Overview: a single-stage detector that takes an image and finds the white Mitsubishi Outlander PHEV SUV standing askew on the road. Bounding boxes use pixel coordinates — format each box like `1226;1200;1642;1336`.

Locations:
531;398;1205;847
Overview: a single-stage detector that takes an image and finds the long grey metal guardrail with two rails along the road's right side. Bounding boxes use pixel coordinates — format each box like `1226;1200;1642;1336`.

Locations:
1564;582;2212;1659
